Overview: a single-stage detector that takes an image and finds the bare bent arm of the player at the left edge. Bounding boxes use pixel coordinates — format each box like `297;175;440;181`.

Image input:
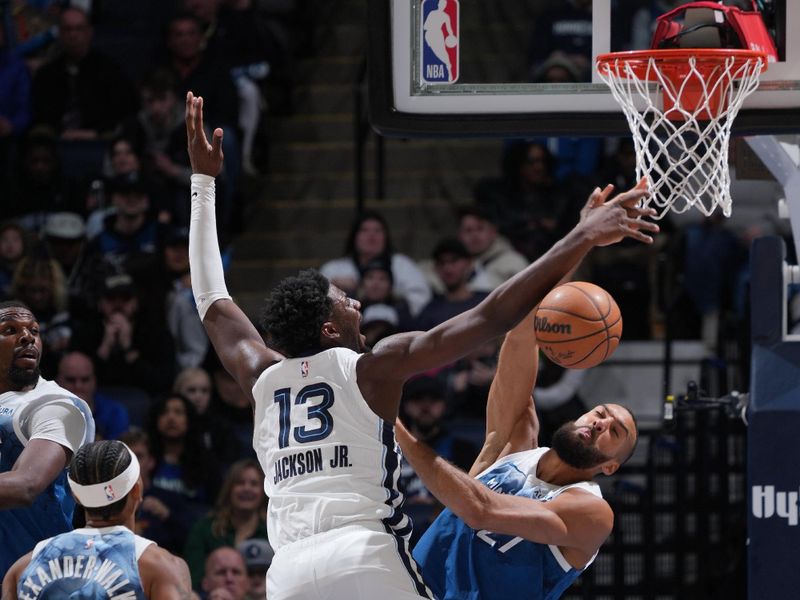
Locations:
0;439;72;509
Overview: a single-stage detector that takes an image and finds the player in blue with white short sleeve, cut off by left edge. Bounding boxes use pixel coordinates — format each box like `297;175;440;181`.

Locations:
0;301;94;577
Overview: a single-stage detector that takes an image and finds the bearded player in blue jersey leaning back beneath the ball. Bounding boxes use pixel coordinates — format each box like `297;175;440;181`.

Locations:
397;312;638;600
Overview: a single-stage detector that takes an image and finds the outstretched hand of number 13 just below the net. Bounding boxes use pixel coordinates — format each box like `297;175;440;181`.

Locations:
578;178;659;246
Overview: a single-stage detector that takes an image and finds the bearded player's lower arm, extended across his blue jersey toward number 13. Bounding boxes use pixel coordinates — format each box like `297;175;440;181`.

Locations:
396;422;614;568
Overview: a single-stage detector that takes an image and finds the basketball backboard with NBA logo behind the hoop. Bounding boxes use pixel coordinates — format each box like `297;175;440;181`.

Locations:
369;0;800;136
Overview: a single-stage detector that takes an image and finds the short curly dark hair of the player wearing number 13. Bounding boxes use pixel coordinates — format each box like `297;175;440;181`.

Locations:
261;269;333;357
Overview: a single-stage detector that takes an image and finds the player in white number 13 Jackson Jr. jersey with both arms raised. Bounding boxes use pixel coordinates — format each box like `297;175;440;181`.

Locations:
186;92;658;600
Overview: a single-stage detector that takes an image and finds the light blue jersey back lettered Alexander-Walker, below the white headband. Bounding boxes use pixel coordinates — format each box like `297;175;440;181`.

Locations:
17;525;153;600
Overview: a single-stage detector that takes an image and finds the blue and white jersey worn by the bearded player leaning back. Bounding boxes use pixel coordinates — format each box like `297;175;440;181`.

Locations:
414;448;601;600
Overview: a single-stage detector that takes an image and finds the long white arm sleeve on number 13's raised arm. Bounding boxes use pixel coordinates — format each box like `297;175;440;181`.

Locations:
189;173;231;320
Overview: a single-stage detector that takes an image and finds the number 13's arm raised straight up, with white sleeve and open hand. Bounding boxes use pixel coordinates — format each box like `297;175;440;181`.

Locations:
186;92;282;401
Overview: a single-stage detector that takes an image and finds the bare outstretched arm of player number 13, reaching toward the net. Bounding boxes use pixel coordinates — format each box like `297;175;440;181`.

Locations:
359;180;658;382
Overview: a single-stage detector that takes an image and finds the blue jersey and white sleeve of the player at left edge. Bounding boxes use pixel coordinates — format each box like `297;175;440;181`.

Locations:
0;379;94;577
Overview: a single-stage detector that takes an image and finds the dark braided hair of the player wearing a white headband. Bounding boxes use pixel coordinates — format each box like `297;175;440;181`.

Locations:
69;440;131;521
